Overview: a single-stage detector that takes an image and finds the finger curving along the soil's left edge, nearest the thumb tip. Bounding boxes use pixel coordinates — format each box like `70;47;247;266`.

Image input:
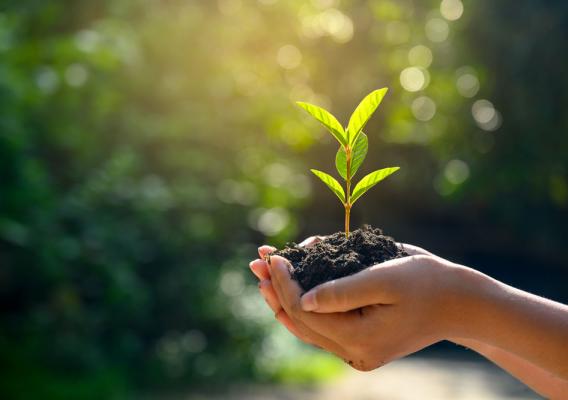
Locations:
269;256;353;340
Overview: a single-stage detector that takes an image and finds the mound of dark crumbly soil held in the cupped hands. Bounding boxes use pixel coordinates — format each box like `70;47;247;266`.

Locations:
274;225;408;291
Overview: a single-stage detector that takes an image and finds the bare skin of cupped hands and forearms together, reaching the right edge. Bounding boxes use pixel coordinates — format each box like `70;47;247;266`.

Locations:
250;237;568;399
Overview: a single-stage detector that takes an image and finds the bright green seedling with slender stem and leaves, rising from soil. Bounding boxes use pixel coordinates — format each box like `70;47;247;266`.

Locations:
296;88;399;237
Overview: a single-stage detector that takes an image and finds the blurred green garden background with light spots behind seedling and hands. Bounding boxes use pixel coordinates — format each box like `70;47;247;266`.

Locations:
0;0;568;399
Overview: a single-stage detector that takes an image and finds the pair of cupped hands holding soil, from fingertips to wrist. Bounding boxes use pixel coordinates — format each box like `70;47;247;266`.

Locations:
250;236;470;371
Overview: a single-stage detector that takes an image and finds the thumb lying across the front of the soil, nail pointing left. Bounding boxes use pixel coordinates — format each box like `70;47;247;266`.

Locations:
301;256;415;313
